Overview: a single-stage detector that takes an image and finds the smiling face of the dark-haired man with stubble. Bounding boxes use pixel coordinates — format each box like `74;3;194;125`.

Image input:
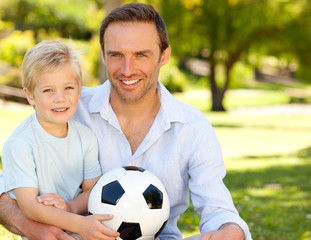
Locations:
103;22;170;103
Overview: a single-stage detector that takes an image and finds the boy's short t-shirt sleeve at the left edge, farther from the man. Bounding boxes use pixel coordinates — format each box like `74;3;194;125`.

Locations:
2;138;38;197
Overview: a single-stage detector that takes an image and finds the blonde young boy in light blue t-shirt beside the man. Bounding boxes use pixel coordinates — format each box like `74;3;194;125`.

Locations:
2;41;119;239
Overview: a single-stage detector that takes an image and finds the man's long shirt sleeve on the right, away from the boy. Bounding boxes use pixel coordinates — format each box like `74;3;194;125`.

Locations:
189;123;252;240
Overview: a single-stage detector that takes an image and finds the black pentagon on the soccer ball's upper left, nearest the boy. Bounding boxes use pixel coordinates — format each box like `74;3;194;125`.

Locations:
102;181;125;205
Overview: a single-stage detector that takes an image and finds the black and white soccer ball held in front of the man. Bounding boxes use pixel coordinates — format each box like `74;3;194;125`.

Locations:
88;166;170;240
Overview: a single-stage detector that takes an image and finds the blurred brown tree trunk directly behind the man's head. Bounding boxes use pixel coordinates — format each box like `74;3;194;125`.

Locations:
97;0;123;83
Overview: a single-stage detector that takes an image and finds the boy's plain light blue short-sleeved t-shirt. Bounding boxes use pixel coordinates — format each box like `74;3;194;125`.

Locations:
2;114;101;201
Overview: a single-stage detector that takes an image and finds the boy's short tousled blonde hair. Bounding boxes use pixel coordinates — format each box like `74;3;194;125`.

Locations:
22;41;82;93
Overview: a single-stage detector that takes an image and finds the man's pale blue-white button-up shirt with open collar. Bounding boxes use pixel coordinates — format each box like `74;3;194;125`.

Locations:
74;81;252;240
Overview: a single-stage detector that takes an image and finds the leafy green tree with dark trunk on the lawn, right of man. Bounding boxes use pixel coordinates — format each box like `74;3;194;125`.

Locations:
161;0;308;111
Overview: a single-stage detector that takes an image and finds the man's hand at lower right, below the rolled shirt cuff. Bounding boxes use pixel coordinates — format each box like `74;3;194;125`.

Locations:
200;224;245;240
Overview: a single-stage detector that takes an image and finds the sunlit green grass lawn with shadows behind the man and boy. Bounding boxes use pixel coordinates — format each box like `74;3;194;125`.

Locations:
0;90;311;240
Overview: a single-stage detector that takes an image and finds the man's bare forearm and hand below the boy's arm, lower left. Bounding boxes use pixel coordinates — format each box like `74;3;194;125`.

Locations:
0;193;74;240
